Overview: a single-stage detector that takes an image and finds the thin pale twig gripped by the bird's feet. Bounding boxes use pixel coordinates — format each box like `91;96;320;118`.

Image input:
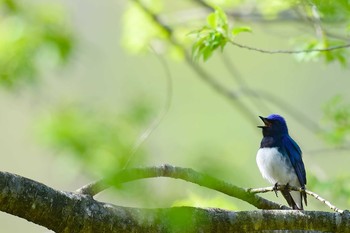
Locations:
248;185;344;213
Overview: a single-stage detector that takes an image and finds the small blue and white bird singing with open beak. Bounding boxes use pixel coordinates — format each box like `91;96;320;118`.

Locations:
256;114;307;210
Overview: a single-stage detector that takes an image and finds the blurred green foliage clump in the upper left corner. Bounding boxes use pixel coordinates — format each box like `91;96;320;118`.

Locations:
0;0;74;89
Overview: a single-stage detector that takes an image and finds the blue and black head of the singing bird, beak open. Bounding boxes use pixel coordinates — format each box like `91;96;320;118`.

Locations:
258;114;288;136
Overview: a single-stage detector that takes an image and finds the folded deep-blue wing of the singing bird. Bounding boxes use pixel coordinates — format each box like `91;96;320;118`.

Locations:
282;135;306;187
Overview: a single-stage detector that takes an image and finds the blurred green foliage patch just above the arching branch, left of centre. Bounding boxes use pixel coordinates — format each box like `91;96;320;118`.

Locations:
39;103;151;176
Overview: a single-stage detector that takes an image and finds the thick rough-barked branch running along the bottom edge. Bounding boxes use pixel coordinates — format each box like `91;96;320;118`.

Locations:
0;172;350;233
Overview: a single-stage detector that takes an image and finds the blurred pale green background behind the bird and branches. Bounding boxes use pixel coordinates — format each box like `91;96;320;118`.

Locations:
0;0;350;233
